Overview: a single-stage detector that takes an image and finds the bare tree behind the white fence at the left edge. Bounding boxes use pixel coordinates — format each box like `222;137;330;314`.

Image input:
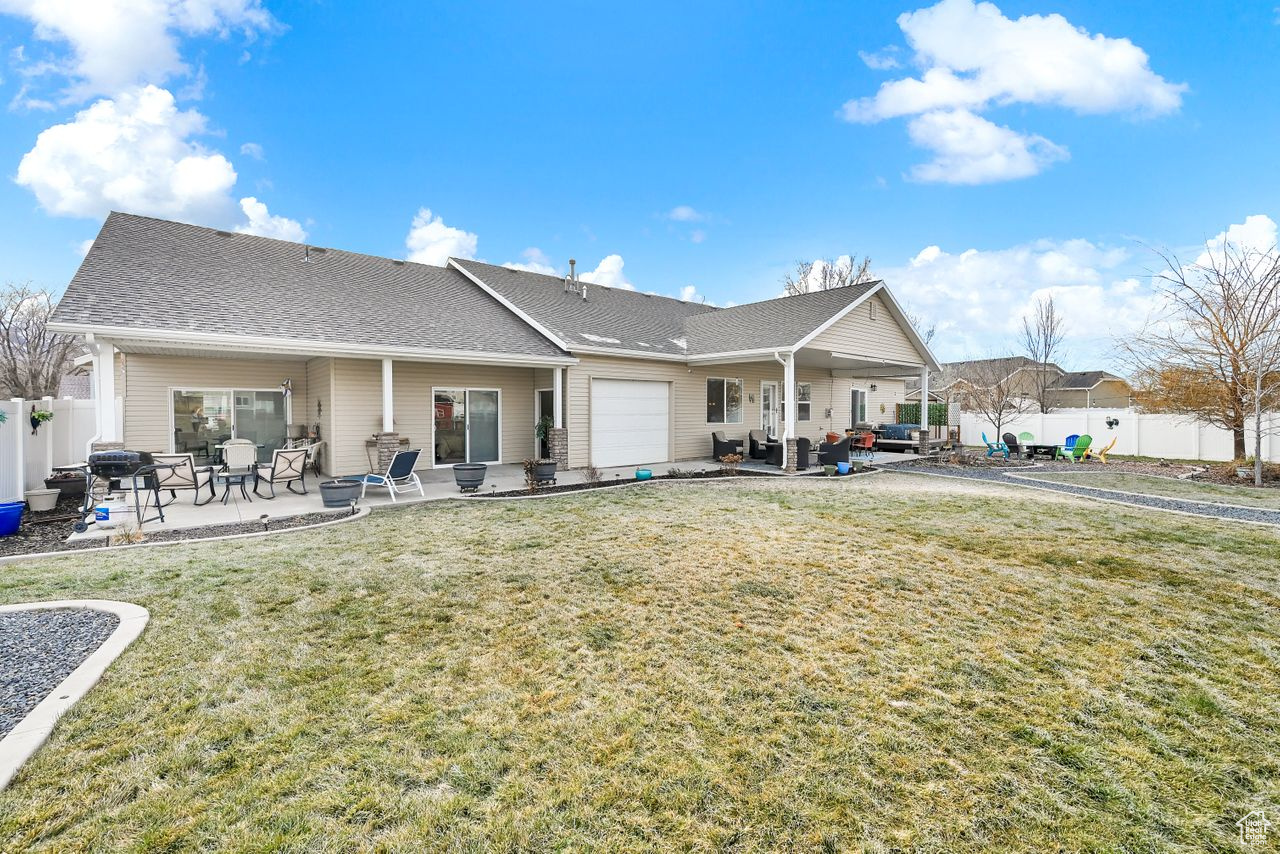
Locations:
0;283;81;401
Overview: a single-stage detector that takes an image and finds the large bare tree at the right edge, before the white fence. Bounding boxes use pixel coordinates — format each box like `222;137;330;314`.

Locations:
1117;242;1280;460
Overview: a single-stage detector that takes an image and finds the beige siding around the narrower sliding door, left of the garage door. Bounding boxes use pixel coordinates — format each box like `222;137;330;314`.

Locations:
332;359;540;474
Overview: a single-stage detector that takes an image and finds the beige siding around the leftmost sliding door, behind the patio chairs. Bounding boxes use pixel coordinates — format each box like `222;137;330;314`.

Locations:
123;353;307;453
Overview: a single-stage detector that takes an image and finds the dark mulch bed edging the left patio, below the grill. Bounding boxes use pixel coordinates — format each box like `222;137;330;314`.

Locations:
0;498;351;557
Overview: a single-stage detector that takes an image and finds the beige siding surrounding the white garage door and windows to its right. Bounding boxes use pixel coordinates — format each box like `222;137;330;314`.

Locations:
567;356;860;469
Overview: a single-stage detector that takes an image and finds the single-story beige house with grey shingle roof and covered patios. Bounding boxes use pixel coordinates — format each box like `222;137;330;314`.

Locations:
51;213;938;475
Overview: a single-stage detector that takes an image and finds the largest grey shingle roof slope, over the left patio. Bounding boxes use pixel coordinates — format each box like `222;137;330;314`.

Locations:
54;213;566;357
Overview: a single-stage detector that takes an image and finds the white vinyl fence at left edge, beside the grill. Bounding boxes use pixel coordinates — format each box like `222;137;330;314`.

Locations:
0;397;97;501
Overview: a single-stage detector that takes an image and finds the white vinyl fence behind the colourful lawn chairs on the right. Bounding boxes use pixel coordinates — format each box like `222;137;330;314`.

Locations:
960;408;1280;462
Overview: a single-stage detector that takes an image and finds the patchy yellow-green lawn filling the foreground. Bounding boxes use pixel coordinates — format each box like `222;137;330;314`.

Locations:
0;474;1280;851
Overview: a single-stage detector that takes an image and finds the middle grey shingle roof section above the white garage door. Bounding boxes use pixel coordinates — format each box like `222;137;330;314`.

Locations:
449;259;716;357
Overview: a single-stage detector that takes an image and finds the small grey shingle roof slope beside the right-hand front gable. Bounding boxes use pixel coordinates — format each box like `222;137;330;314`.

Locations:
685;282;881;356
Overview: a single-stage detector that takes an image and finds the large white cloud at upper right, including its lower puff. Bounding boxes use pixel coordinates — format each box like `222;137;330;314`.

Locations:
841;0;1187;183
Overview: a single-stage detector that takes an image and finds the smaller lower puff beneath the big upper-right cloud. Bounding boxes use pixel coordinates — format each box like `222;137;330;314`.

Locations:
908;110;1070;184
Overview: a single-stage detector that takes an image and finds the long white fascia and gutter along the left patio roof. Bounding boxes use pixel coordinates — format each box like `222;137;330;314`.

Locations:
49;323;577;367
